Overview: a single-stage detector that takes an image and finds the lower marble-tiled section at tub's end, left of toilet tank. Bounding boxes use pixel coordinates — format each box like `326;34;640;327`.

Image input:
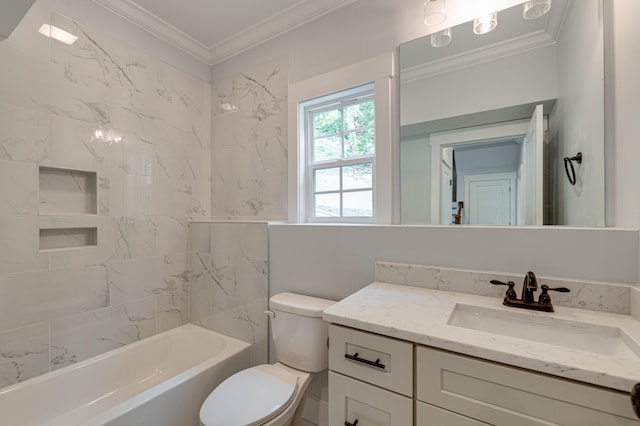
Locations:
189;221;269;365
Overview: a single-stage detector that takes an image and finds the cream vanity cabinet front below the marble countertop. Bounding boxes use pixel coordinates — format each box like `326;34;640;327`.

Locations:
329;324;640;426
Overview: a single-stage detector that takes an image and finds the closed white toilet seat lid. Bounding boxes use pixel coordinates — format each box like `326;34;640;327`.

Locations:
200;364;298;426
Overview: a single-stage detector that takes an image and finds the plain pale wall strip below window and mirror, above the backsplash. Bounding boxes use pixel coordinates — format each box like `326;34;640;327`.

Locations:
269;225;638;300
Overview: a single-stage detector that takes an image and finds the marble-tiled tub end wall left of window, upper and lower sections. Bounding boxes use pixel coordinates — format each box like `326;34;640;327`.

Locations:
204;52;288;365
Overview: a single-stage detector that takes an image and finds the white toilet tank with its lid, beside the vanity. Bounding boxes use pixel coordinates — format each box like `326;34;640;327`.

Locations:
269;293;335;373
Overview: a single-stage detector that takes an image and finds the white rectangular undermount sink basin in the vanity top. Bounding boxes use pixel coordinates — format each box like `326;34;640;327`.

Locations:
447;303;640;360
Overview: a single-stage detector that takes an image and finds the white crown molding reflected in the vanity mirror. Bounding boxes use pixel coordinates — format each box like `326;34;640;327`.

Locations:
400;30;556;84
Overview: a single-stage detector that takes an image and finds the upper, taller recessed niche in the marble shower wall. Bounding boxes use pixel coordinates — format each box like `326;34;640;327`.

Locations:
38;167;98;215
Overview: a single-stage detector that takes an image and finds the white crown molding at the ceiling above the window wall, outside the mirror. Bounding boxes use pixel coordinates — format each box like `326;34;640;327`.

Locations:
210;0;357;65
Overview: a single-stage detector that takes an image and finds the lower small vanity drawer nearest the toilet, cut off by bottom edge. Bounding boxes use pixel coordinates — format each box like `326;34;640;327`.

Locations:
329;371;413;426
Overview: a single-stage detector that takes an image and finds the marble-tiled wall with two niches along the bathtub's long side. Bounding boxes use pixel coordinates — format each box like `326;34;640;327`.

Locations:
0;2;210;387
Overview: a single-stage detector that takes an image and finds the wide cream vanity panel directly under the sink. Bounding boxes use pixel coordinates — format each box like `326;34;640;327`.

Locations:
416;346;640;426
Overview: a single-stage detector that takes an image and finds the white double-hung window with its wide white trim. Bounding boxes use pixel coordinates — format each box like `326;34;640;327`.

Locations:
287;53;392;224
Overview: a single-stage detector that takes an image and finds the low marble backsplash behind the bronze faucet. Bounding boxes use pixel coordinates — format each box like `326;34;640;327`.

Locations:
375;262;640;316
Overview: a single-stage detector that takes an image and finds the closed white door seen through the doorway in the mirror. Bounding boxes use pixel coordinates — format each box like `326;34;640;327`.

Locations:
464;173;516;225
